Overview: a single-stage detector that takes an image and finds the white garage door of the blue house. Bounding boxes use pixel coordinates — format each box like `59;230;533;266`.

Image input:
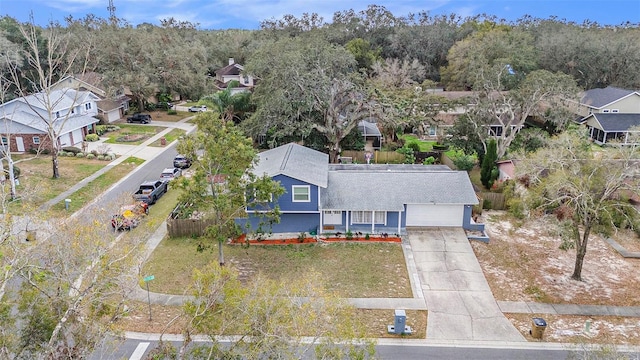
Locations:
407;204;464;226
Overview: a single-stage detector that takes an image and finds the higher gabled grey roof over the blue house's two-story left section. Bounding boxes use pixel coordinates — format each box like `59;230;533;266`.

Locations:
253;143;329;188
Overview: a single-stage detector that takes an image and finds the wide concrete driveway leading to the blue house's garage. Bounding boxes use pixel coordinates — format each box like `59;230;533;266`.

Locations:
407;227;526;341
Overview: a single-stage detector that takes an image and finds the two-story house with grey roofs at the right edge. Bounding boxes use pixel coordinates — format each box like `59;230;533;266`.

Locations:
578;86;640;145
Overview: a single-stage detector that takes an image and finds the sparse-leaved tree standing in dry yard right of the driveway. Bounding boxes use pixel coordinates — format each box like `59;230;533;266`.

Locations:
516;130;640;281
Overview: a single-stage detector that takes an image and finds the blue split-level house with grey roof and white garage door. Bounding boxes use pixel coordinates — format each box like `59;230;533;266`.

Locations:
237;143;484;238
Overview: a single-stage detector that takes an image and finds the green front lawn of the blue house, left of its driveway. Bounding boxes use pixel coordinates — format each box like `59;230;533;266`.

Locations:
143;238;412;297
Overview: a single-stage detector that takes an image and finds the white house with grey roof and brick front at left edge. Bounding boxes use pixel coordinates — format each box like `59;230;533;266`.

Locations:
0;89;100;152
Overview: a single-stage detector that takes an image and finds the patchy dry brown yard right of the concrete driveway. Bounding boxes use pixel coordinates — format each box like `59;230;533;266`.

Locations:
472;211;640;344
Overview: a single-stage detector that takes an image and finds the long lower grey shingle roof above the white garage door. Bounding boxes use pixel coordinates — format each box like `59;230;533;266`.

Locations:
320;165;478;211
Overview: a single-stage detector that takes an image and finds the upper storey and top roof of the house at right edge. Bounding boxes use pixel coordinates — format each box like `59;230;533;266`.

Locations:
578;86;640;119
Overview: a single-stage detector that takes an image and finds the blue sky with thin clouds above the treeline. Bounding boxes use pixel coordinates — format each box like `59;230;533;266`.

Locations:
0;0;640;30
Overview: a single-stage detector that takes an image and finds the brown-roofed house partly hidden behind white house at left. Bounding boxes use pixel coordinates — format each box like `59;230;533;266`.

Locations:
51;72;130;123
